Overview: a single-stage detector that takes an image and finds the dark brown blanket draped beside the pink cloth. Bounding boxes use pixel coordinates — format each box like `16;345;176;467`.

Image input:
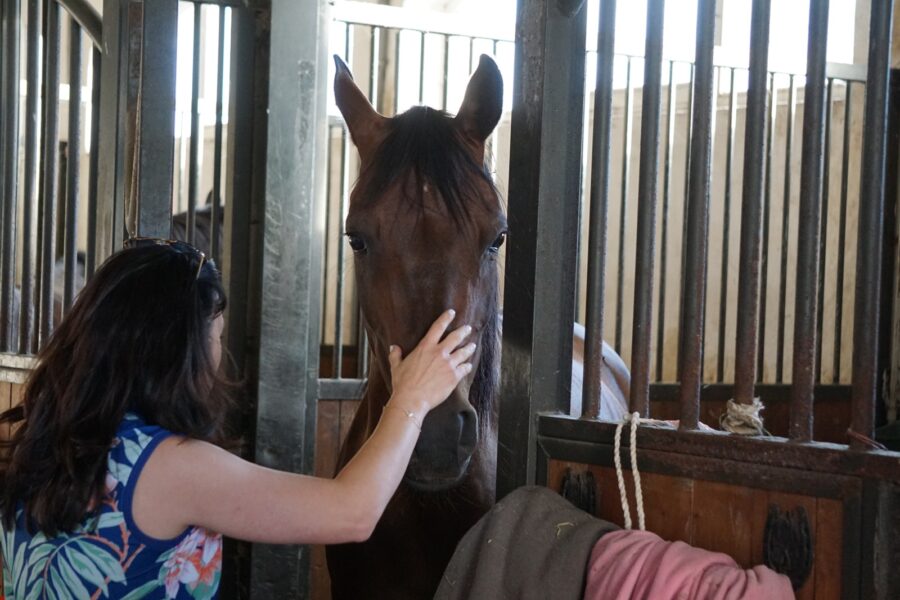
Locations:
435;487;619;600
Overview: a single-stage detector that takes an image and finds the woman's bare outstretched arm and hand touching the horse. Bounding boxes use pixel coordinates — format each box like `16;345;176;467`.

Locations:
133;311;474;543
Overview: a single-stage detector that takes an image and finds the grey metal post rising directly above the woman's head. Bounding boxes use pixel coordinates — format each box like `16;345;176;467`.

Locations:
132;0;179;238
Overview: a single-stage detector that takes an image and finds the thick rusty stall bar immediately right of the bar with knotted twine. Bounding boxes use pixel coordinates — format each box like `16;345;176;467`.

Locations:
790;0;828;441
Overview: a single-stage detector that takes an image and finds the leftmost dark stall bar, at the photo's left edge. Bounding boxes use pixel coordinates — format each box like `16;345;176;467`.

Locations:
0;0;20;352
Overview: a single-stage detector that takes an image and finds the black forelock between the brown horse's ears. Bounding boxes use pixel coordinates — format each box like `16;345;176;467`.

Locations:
357;106;497;224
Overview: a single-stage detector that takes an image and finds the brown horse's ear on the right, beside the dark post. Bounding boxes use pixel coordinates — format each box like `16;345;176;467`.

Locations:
456;54;503;145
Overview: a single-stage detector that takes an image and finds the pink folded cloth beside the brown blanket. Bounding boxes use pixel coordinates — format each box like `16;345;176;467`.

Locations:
584;530;794;600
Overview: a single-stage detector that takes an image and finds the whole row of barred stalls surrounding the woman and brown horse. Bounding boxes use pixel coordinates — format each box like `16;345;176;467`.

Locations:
0;0;900;598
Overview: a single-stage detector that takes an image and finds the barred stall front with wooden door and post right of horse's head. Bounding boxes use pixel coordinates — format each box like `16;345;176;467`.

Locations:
497;0;900;598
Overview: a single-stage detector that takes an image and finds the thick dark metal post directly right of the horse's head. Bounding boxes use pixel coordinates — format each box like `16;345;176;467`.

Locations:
497;0;587;498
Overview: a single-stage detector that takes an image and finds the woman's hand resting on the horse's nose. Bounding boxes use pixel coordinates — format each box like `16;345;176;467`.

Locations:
388;309;475;414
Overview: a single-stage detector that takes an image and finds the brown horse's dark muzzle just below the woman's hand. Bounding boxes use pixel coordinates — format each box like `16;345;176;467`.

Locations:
404;390;478;492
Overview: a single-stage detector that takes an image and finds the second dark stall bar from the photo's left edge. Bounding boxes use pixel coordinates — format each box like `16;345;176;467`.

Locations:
18;0;41;354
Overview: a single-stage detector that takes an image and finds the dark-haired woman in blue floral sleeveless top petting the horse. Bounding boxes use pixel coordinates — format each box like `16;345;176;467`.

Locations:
0;238;475;600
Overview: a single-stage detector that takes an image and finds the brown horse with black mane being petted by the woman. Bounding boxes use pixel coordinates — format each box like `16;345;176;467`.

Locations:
326;55;628;600
